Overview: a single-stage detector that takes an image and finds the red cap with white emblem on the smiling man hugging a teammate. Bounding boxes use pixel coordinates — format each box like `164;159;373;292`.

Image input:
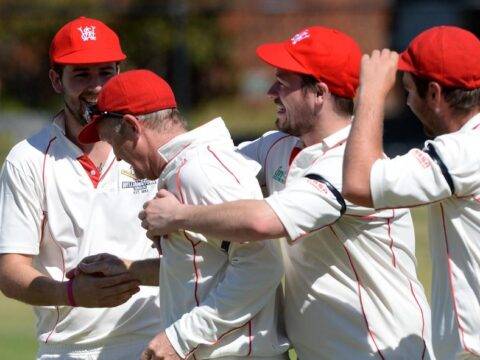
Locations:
257;26;362;98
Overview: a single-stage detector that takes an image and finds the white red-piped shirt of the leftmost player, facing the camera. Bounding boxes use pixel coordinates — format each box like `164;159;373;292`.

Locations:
0;114;159;357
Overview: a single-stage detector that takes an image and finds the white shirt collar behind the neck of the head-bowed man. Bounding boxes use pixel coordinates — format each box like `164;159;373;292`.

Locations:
158;117;233;163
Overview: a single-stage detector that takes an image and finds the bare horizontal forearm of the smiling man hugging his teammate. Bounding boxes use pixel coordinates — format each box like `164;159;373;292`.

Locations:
175;200;286;242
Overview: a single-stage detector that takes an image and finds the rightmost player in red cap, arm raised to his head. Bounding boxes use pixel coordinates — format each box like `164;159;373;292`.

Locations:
343;26;480;360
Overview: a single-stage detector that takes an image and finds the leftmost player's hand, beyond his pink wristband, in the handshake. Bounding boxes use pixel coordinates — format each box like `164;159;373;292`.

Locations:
72;273;140;308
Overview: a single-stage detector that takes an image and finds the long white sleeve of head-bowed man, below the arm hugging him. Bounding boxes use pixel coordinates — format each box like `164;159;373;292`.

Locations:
166;241;283;357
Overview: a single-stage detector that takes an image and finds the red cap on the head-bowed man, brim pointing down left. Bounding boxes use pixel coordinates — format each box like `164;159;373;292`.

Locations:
78;70;177;144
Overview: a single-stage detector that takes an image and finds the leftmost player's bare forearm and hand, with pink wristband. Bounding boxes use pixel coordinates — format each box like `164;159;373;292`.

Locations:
0;254;139;307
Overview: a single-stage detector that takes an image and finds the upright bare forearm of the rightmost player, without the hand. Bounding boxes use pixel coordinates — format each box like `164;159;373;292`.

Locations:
343;89;385;207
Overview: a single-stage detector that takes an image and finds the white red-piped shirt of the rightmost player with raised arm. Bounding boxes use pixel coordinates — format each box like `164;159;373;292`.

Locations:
370;114;480;360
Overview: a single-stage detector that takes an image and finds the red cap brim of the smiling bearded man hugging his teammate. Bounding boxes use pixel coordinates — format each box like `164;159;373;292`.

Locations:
257;43;310;74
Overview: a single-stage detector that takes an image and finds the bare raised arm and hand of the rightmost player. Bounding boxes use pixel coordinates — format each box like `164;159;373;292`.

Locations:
342;49;398;207
